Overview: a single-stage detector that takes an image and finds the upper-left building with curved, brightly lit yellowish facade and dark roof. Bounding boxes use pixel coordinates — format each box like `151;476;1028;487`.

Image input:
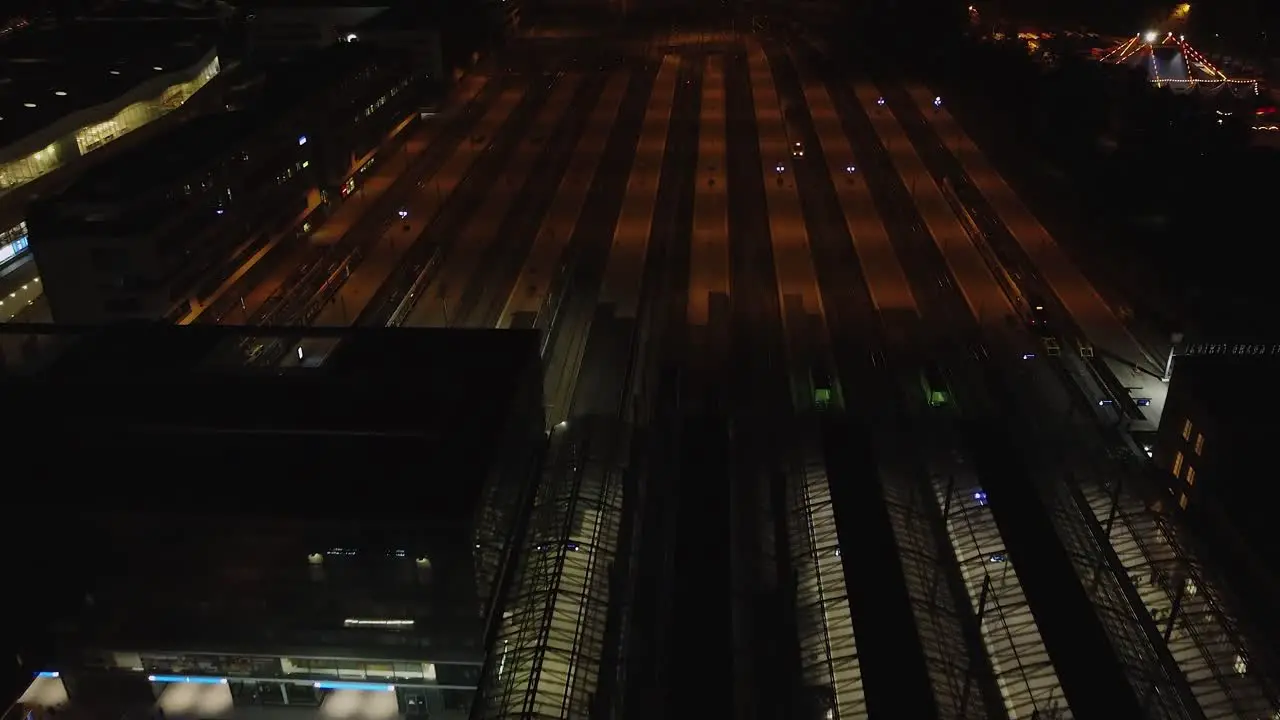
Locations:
0;4;224;272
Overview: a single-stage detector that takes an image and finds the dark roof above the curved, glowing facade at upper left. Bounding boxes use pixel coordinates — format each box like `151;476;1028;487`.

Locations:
0;4;220;147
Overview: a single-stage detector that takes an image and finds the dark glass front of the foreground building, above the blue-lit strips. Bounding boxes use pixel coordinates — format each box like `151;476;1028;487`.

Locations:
63;512;483;661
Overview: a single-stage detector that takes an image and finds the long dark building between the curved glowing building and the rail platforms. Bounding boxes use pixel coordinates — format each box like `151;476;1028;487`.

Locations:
29;44;425;323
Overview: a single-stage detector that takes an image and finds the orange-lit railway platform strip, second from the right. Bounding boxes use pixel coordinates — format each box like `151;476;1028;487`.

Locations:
854;82;1019;329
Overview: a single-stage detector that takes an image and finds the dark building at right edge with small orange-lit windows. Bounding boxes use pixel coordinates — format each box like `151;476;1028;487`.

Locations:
1152;343;1280;641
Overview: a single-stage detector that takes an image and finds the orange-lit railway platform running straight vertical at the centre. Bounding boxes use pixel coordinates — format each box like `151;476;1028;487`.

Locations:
689;55;730;325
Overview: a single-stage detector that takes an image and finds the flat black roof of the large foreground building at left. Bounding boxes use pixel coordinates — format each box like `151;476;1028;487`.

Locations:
0;325;540;497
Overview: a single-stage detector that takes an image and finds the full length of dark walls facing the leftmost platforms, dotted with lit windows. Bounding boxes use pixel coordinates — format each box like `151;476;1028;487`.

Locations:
33;48;425;323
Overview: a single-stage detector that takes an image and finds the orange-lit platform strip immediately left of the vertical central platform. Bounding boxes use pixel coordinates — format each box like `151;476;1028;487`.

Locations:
600;55;680;318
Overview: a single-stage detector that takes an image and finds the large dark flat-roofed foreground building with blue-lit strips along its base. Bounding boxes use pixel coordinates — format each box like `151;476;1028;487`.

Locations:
0;325;545;720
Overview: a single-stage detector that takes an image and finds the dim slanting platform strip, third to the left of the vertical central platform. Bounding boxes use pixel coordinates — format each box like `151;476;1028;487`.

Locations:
406;74;582;327
